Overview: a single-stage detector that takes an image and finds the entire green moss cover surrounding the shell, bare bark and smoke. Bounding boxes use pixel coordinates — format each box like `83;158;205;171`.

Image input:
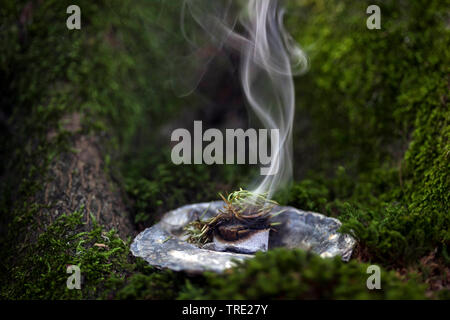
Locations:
0;0;450;299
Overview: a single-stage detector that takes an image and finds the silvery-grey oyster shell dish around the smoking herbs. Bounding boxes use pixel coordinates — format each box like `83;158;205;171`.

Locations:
131;201;356;273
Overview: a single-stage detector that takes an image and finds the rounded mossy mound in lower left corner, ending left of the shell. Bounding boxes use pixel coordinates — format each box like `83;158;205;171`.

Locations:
1;212;132;299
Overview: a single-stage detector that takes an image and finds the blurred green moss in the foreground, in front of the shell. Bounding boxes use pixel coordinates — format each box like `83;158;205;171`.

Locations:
179;249;425;300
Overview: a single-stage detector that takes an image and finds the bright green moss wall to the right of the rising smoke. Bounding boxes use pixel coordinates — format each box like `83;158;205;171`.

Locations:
287;0;450;266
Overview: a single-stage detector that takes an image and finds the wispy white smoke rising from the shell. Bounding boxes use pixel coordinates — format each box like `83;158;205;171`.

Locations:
182;0;307;197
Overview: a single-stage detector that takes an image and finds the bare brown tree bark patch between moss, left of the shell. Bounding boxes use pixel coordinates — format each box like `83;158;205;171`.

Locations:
37;113;135;239
